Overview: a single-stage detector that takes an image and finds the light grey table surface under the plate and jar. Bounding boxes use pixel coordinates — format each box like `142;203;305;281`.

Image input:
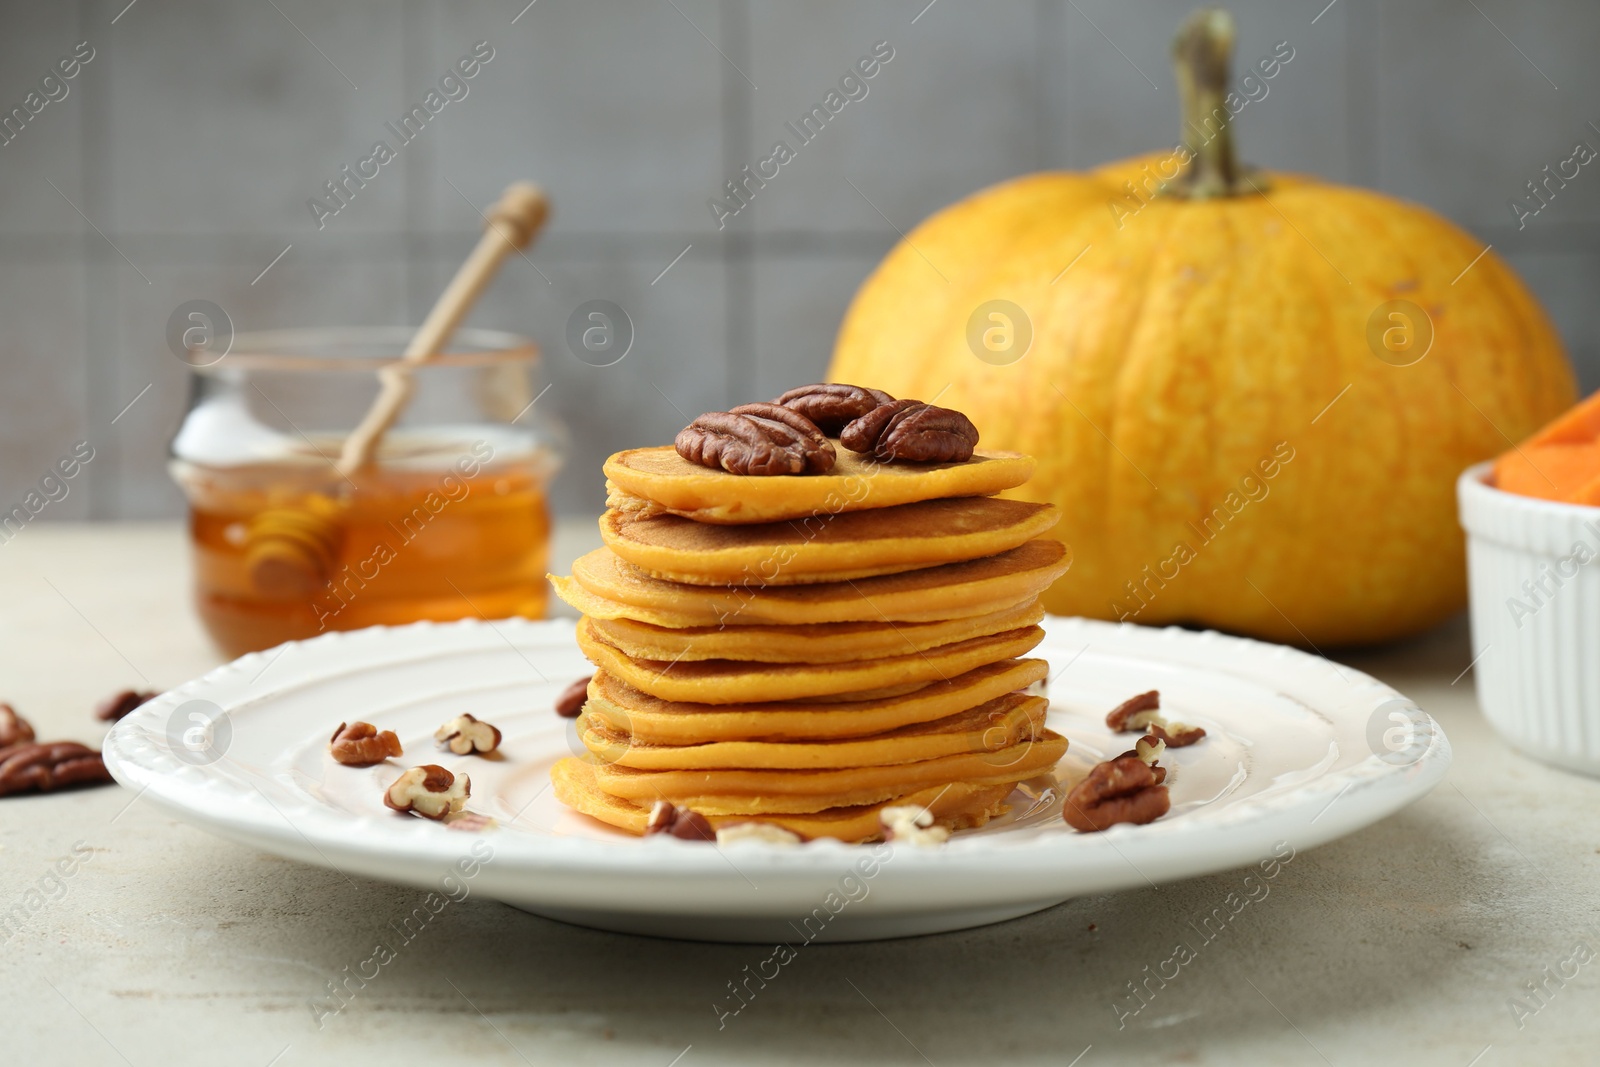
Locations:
0;523;1600;1067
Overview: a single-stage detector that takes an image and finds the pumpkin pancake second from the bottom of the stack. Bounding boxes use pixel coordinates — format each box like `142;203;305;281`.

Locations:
594;728;1067;816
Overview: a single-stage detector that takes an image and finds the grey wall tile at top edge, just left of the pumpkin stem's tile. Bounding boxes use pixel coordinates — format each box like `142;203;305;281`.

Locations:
745;0;1035;234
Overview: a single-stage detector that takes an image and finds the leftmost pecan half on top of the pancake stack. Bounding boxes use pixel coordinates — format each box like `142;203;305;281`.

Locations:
672;403;835;475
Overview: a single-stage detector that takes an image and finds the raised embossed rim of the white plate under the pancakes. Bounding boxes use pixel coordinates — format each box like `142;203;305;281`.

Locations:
102;616;1451;885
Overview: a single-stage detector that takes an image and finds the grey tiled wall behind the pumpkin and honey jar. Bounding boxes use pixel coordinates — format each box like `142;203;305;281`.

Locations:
0;0;1600;518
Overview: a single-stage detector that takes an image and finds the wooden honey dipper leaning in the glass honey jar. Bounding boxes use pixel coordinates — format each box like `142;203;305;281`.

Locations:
245;182;550;598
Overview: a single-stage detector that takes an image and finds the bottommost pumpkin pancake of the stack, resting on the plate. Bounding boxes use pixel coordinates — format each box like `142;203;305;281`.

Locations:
550;757;1013;845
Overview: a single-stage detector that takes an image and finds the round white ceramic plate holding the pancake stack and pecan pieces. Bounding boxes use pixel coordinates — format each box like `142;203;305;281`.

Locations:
104;619;1450;942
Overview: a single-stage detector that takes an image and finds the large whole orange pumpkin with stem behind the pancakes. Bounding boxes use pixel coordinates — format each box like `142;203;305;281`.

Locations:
829;11;1574;645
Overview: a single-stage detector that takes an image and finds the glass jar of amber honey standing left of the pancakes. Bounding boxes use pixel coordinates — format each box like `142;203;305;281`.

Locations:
170;328;563;656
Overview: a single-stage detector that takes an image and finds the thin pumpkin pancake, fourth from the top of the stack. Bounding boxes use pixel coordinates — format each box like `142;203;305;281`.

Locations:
589;600;1045;664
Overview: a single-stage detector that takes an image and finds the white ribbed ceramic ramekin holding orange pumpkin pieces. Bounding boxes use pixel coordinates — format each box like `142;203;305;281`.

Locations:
1456;462;1600;774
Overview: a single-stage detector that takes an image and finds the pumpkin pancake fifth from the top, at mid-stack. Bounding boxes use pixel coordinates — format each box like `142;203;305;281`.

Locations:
578;619;1045;704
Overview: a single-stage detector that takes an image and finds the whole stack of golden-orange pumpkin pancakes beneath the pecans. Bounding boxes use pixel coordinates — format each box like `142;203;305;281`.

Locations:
552;448;1069;841
